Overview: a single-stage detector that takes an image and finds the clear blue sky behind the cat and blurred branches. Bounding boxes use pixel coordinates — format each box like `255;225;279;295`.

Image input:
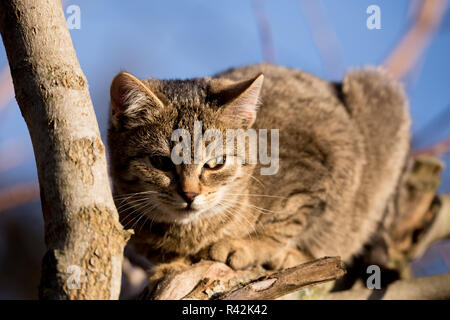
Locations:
0;0;450;191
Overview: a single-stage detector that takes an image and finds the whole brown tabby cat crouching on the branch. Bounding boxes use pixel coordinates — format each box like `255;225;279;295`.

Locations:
108;64;410;282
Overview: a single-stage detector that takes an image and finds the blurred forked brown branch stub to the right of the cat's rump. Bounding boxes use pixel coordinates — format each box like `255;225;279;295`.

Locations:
385;155;450;278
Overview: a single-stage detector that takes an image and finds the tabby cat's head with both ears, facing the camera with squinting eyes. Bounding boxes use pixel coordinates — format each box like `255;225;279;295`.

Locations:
108;72;263;223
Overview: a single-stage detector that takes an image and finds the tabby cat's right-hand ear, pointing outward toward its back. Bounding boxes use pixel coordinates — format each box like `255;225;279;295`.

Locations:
215;74;264;128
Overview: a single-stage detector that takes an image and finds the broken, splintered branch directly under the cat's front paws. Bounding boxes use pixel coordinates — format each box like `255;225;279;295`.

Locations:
141;257;345;300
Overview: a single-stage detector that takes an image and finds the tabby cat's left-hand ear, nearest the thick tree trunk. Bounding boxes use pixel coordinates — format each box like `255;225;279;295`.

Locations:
110;72;164;127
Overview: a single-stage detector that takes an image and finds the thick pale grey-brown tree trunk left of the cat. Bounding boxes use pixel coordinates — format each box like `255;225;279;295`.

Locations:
0;0;129;299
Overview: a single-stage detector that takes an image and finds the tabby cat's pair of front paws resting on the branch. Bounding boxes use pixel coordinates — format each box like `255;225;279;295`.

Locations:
204;238;312;270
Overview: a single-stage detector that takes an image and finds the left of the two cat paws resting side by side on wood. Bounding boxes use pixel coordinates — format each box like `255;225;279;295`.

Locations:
208;240;258;270
